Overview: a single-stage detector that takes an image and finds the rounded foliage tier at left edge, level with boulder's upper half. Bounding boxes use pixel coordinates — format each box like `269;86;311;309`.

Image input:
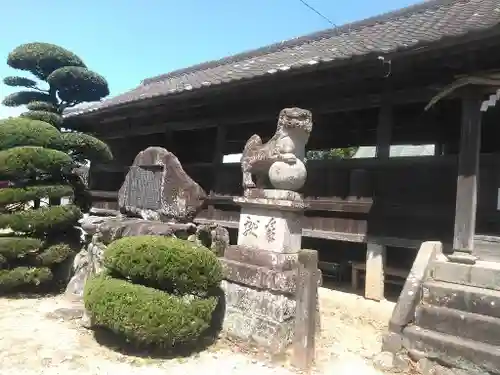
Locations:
0;146;73;179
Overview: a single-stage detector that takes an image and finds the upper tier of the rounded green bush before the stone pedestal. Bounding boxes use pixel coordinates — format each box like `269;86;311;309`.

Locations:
104;236;222;295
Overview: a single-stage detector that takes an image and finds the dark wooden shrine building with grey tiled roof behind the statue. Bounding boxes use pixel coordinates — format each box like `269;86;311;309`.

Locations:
65;0;500;299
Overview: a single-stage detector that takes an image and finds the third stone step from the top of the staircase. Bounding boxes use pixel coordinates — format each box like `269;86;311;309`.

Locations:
415;305;500;345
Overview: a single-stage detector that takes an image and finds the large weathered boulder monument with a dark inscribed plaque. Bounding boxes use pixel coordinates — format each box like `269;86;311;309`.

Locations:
118;147;206;222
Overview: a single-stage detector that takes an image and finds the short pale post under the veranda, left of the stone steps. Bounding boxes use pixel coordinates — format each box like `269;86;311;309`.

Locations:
365;243;386;301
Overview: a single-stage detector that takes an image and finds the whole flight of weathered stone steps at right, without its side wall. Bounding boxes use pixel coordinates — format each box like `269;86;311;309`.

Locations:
403;259;500;374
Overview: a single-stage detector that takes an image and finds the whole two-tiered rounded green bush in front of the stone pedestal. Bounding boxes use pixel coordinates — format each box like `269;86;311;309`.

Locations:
84;236;222;348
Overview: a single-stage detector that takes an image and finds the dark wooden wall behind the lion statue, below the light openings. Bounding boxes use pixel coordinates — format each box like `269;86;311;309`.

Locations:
89;154;500;248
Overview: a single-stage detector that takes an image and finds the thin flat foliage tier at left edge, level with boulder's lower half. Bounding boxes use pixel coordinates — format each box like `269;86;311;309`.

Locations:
0;185;73;207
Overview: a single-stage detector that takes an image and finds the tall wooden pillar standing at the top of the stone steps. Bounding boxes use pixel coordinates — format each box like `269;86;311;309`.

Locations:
448;89;482;264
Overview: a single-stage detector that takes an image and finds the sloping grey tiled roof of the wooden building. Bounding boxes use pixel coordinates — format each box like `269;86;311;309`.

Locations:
66;0;500;116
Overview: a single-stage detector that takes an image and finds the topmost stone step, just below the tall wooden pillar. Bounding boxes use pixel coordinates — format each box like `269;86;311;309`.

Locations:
428;257;500;291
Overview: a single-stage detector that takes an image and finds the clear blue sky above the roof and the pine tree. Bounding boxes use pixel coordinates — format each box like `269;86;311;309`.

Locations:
0;0;418;118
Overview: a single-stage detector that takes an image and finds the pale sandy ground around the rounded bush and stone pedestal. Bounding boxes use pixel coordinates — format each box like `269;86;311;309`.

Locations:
0;288;402;375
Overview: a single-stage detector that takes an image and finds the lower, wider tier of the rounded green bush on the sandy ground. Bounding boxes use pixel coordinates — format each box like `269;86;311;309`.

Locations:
84;275;217;347
